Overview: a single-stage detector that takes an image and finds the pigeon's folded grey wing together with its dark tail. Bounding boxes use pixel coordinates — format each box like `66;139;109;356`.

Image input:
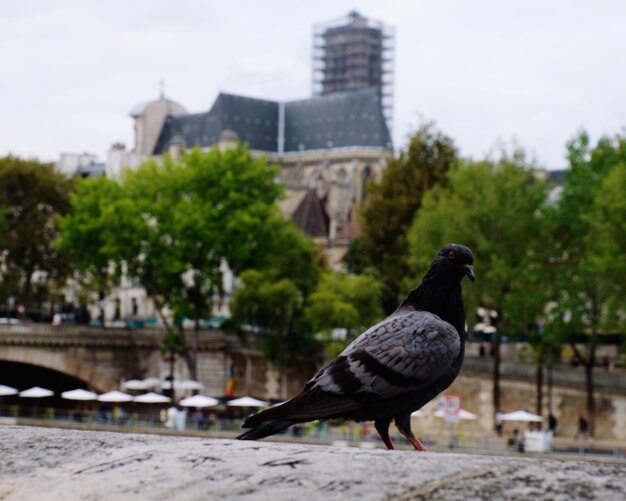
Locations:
244;310;461;428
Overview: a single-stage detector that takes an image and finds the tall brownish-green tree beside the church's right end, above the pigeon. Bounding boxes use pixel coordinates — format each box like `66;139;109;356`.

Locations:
358;123;457;313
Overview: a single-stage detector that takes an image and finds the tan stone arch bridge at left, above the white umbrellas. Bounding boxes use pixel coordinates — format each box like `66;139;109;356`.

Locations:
0;323;240;395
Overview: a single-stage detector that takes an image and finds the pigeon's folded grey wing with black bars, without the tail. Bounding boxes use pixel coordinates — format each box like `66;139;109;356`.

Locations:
307;311;461;400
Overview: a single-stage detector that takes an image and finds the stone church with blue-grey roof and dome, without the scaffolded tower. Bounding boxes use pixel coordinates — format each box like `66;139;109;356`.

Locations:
107;88;393;266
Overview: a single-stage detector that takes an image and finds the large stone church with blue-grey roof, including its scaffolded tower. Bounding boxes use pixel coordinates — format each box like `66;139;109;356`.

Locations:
59;12;393;321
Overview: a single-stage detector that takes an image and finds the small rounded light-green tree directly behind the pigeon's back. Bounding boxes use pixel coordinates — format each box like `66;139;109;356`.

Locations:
305;271;384;357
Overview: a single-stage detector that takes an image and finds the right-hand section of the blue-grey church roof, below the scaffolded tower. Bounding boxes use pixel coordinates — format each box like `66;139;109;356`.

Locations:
284;89;392;151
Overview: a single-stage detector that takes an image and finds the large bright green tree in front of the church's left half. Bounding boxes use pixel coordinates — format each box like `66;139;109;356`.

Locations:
59;145;282;378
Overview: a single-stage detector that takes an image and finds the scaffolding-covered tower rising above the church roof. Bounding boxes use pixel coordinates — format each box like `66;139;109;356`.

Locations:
313;11;395;130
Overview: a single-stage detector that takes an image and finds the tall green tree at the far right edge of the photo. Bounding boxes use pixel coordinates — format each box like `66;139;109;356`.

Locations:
547;131;626;435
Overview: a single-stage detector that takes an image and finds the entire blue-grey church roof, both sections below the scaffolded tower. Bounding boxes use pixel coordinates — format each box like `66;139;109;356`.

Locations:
154;89;392;155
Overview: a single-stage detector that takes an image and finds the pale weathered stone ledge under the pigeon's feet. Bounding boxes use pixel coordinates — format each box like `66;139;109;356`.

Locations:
0;426;626;501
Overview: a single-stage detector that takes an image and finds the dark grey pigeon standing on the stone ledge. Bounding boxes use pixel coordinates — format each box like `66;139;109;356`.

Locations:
237;244;475;451
